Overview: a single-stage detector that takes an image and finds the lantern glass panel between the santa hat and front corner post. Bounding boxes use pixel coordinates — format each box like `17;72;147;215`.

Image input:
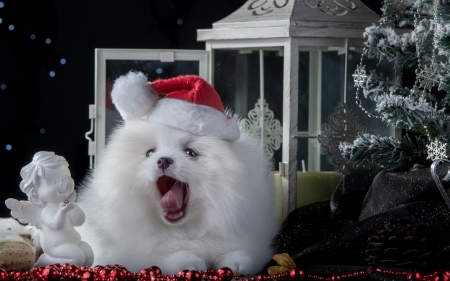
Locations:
213;48;283;166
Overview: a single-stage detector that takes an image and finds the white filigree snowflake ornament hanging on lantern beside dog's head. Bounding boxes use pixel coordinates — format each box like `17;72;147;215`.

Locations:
239;99;283;158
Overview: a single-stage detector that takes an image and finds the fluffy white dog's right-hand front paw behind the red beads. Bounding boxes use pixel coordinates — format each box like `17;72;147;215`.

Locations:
217;251;258;276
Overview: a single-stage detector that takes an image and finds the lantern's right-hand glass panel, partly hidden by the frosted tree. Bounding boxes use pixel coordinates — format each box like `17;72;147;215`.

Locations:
297;47;395;171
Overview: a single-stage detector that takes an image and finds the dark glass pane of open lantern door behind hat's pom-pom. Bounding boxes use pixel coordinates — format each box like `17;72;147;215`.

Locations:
105;60;199;140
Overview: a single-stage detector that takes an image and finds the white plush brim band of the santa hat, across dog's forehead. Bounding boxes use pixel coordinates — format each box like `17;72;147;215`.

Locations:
148;98;240;140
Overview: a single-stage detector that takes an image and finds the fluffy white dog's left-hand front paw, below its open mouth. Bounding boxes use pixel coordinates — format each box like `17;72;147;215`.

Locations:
161;251;206;274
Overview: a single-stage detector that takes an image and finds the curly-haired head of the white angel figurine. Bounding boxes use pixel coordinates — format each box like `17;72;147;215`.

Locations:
20;151;76;206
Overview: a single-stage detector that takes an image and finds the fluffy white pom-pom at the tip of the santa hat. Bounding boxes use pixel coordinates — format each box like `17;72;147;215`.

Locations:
111;71;158;121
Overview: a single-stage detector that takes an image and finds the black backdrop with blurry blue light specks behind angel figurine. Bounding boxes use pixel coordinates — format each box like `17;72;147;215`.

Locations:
0;0;381;217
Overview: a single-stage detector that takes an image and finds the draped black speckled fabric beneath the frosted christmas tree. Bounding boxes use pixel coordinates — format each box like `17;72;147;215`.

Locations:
274;165;450;273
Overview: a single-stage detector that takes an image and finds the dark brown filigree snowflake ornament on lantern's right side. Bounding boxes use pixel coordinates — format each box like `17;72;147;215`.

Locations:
318;103;367;174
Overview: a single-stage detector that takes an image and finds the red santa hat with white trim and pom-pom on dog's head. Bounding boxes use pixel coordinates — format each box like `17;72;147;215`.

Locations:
111;72;240;140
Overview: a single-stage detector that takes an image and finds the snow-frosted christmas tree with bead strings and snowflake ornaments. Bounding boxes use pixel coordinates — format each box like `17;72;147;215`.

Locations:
339;0;450;168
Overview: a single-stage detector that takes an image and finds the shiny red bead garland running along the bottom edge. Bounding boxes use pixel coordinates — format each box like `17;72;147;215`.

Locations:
0;264;450;281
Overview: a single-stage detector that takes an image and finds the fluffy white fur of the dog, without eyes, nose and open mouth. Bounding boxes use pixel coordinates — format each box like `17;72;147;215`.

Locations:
78;119;277;275
